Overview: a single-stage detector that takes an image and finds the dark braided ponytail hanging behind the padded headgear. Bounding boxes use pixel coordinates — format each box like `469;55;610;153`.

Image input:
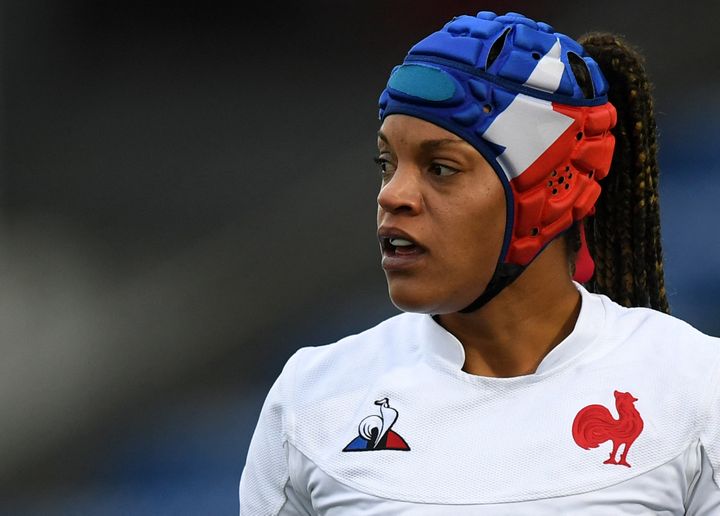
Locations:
567;33;669;312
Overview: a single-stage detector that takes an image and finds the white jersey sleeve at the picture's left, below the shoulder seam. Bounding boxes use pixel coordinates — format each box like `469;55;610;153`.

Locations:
240;353;310;516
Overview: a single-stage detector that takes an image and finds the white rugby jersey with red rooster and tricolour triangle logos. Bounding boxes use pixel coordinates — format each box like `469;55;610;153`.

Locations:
240;285;720;516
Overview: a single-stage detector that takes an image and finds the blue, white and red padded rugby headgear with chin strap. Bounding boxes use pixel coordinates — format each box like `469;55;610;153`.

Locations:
380;11;616;311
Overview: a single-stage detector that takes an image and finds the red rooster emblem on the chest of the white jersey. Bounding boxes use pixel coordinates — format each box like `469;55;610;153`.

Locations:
573;391;644;468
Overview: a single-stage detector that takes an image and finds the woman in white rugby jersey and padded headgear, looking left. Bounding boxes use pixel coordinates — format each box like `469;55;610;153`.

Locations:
240;12;720;516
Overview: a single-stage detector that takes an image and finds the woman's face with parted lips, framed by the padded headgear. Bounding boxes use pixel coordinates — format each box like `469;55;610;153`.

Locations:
377;115;505;314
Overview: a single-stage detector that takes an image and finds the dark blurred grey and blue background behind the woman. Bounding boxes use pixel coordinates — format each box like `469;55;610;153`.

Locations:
0;0;720;515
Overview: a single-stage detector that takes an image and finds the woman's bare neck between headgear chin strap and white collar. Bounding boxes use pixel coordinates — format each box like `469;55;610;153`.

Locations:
437;239;581;377
